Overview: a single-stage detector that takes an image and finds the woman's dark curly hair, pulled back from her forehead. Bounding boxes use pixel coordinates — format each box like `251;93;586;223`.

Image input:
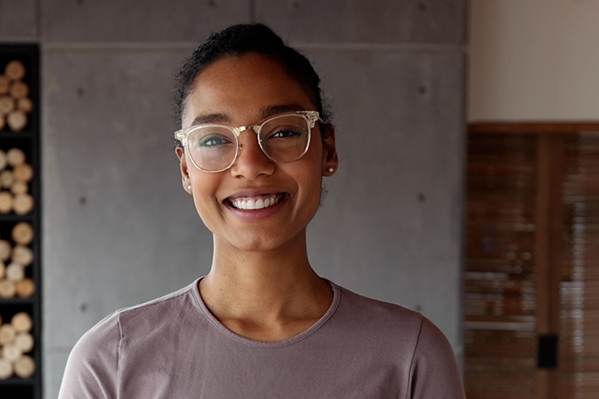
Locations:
175;24;330;128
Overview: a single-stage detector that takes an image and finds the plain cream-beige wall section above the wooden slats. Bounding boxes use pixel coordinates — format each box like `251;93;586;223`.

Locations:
468;0;599;121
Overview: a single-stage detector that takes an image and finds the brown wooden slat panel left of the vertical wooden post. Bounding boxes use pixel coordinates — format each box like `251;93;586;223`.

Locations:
465;135;537;399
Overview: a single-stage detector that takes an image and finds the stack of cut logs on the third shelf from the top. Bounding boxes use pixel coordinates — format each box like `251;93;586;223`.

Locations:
0;222;35;299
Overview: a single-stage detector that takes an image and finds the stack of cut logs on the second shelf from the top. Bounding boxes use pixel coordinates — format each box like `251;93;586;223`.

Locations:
0;148;34;215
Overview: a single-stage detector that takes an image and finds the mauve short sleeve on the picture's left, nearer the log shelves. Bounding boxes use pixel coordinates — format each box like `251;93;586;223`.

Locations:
58;313;121;399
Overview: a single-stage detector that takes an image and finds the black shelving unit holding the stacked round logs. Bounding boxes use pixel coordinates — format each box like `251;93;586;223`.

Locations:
0;43;42;399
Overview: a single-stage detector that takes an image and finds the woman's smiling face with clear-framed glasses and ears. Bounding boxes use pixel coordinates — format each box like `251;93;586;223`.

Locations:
176;52;338;251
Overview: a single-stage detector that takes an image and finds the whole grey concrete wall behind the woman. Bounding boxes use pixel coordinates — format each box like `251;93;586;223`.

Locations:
0;0;466;398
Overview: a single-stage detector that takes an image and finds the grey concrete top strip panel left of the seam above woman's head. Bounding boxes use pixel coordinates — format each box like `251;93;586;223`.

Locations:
41;0;250;43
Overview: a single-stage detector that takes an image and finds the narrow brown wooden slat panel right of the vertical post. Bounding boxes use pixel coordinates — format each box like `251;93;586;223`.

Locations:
559;133;599;399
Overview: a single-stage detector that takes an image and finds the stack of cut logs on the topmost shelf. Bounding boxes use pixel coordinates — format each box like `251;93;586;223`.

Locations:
0;60;33;132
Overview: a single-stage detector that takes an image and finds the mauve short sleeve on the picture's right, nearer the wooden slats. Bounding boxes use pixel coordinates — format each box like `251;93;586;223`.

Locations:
410;318;466;399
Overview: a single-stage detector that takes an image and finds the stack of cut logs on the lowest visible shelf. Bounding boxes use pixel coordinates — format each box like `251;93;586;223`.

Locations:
0;312;35;380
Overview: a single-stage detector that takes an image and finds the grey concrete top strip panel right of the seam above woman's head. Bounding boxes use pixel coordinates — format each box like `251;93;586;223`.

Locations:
256;0;466;44
